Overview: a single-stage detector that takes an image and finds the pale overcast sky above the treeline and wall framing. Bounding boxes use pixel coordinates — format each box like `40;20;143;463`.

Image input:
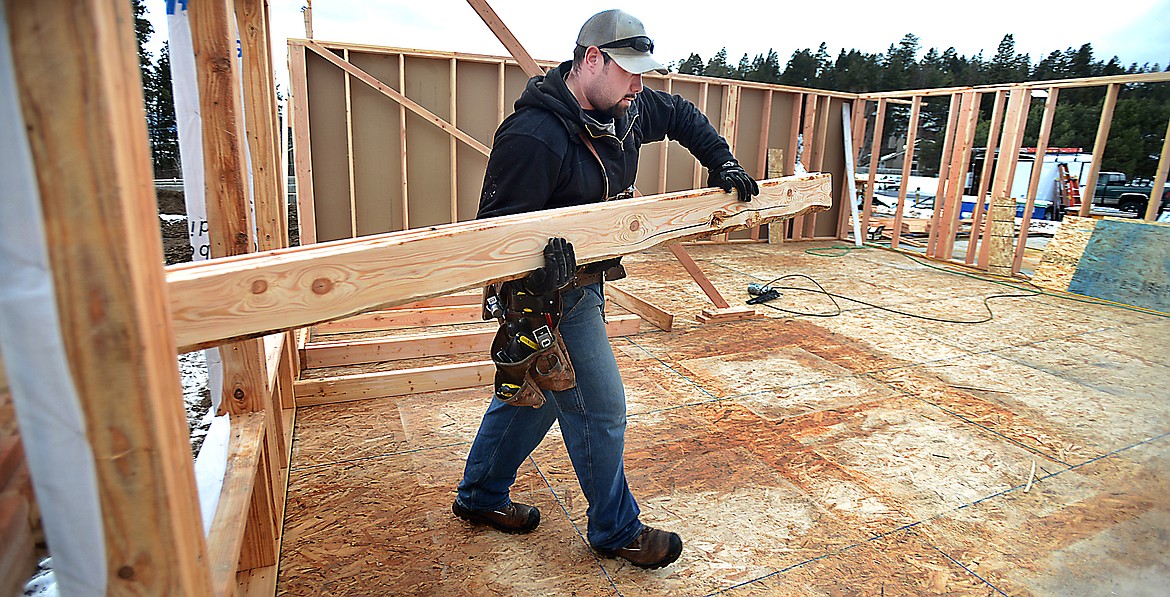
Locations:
146;0;1170;87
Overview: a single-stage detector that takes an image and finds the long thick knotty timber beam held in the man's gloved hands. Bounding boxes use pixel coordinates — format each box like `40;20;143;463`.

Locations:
167;174;832;351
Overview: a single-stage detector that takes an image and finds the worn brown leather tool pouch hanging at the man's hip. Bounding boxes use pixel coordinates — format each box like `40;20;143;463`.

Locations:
491;318;577;409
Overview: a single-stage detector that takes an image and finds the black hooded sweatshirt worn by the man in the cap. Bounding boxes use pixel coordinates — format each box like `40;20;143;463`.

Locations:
479;61;735;218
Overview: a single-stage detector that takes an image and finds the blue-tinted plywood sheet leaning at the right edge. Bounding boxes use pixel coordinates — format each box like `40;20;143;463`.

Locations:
1068;220;1170;313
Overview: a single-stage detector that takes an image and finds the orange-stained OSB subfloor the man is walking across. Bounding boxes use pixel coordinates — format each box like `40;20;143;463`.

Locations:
280;239;1170;596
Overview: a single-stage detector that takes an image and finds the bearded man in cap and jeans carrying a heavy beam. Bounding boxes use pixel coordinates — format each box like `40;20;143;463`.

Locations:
453;11;759;569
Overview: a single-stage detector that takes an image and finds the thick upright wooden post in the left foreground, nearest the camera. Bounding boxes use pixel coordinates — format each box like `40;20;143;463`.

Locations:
8;0;212;595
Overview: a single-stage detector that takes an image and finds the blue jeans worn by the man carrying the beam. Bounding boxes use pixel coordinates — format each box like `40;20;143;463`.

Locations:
455;284;642;549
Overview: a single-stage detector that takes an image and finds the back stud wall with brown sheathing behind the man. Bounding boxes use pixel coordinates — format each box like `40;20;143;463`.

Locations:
289;40;852;241
